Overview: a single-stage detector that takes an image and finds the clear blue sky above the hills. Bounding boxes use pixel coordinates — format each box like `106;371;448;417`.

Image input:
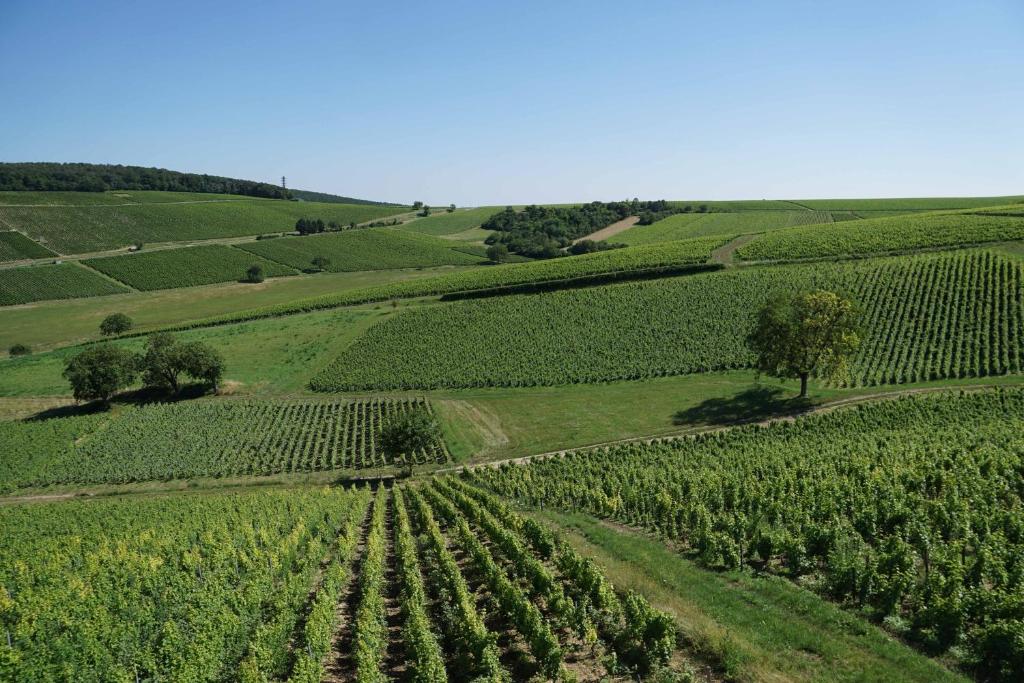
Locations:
0;0;1024;206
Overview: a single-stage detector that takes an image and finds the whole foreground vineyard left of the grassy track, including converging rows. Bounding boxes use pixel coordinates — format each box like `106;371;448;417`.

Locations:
0;480;687;682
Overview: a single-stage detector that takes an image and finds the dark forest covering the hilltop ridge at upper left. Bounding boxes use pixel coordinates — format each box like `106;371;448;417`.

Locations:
0;163;292;199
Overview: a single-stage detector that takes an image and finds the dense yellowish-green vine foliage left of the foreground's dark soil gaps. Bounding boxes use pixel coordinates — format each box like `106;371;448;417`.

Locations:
0;488;369;681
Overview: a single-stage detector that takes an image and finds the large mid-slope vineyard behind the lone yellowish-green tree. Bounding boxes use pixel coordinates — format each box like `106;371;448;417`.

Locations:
311;249;1024;391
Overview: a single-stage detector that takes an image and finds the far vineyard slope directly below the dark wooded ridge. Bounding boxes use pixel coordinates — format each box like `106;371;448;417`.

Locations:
0;199;408;254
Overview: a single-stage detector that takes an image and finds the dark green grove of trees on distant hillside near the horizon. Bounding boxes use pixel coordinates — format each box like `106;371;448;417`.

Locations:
481;199;669;258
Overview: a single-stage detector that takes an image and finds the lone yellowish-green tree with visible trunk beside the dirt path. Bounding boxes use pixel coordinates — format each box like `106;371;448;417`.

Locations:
748;291;860;398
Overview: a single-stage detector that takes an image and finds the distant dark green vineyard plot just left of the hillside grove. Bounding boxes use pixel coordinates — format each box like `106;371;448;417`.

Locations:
239;228;480;272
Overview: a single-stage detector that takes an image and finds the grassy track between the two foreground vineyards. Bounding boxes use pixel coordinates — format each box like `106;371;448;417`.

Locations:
534;512;967;682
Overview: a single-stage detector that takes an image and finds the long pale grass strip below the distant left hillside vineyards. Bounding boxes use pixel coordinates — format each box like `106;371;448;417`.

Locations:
0;266;479;353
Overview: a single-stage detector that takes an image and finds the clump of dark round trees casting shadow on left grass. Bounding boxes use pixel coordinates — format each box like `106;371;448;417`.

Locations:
63;332;224;403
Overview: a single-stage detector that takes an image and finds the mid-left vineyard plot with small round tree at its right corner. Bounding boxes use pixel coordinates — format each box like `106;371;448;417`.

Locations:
0;398;449;489
